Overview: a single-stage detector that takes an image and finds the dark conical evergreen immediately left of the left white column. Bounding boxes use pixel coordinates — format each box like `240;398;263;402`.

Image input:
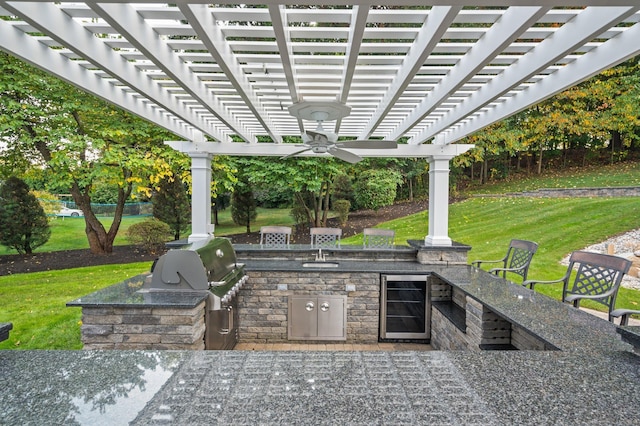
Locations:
151;176;191;240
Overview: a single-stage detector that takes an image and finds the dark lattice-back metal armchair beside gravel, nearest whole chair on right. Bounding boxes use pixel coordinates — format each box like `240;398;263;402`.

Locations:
522;251;631;322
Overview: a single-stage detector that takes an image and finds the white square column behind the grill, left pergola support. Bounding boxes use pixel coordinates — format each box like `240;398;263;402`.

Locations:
188;152;213;243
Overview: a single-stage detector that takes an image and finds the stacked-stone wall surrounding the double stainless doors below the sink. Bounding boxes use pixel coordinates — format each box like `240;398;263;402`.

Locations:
238;271;380;343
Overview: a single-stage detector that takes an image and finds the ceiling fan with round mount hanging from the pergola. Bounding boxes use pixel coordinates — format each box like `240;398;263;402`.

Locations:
282;102;398;164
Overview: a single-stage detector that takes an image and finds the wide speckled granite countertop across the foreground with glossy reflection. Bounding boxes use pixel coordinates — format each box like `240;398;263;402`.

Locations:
0;351;640;426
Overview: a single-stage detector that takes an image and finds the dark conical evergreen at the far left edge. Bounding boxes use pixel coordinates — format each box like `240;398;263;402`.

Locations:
0;177;51;254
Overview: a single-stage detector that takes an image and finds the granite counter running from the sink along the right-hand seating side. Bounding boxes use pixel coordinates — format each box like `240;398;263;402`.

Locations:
245;260;630;351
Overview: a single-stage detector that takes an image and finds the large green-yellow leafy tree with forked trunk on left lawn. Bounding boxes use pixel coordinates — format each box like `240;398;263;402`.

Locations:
0;53;175;253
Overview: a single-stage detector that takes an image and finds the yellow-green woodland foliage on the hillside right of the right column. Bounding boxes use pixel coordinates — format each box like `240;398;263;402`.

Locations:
455;57;640;183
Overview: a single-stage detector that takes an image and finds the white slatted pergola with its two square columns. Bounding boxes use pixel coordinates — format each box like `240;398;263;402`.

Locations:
0;0;640;246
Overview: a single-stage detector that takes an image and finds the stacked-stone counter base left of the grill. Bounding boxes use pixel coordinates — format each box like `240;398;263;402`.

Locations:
81;302;205;350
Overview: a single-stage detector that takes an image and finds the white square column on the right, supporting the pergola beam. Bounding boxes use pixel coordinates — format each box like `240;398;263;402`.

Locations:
424;155;453;246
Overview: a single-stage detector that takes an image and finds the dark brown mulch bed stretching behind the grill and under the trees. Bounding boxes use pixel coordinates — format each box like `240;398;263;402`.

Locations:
0;200;428;276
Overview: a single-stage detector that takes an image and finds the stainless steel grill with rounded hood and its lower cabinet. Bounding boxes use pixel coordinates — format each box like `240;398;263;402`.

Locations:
150;238;247;349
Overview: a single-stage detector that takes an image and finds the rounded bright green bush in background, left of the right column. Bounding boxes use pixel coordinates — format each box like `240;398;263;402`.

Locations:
354;169;402;210
